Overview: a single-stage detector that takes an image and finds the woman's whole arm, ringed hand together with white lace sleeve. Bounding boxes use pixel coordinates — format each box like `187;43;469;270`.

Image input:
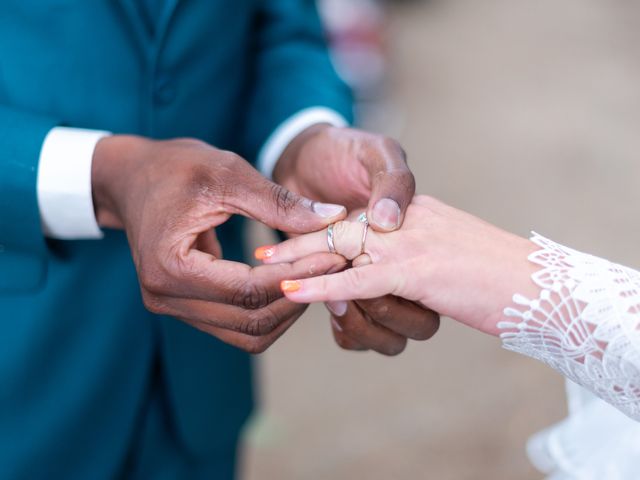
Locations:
271;196;640;420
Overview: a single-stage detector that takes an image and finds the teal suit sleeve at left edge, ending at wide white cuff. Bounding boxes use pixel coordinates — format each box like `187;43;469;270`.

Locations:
0;105;58;288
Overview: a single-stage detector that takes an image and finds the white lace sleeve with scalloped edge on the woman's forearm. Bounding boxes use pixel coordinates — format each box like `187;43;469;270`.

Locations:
498;233;640;420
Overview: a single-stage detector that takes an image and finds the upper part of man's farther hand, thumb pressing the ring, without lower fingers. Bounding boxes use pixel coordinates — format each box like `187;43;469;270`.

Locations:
273;124;416;232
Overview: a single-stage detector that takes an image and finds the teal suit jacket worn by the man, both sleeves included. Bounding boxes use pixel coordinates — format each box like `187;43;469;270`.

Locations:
0;0;351;479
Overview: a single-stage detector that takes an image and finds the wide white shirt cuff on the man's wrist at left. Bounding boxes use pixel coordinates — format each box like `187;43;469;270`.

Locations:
37;127;110;240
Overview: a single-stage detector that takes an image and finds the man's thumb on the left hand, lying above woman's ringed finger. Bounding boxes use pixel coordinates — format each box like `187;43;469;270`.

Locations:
233;172;347;233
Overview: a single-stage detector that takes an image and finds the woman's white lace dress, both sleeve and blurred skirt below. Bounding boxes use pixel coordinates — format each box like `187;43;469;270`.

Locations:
499;234;640;480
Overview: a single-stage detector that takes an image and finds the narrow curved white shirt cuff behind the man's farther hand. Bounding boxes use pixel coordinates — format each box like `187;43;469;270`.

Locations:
258;107;348;178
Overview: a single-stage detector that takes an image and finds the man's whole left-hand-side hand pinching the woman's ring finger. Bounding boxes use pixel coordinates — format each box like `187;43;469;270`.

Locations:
92;136;346;353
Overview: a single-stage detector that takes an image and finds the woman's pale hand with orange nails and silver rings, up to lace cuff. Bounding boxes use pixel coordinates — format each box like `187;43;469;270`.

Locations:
266;196;538;334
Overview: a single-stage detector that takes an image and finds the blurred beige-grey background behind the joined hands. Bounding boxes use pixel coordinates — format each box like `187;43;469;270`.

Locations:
243;0;640;480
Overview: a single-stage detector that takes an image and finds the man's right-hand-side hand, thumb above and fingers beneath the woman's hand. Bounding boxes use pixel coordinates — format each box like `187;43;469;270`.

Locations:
274;125;439;355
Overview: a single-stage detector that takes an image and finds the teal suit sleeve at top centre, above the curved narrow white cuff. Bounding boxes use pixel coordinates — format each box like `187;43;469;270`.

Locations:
244;0;353;159
